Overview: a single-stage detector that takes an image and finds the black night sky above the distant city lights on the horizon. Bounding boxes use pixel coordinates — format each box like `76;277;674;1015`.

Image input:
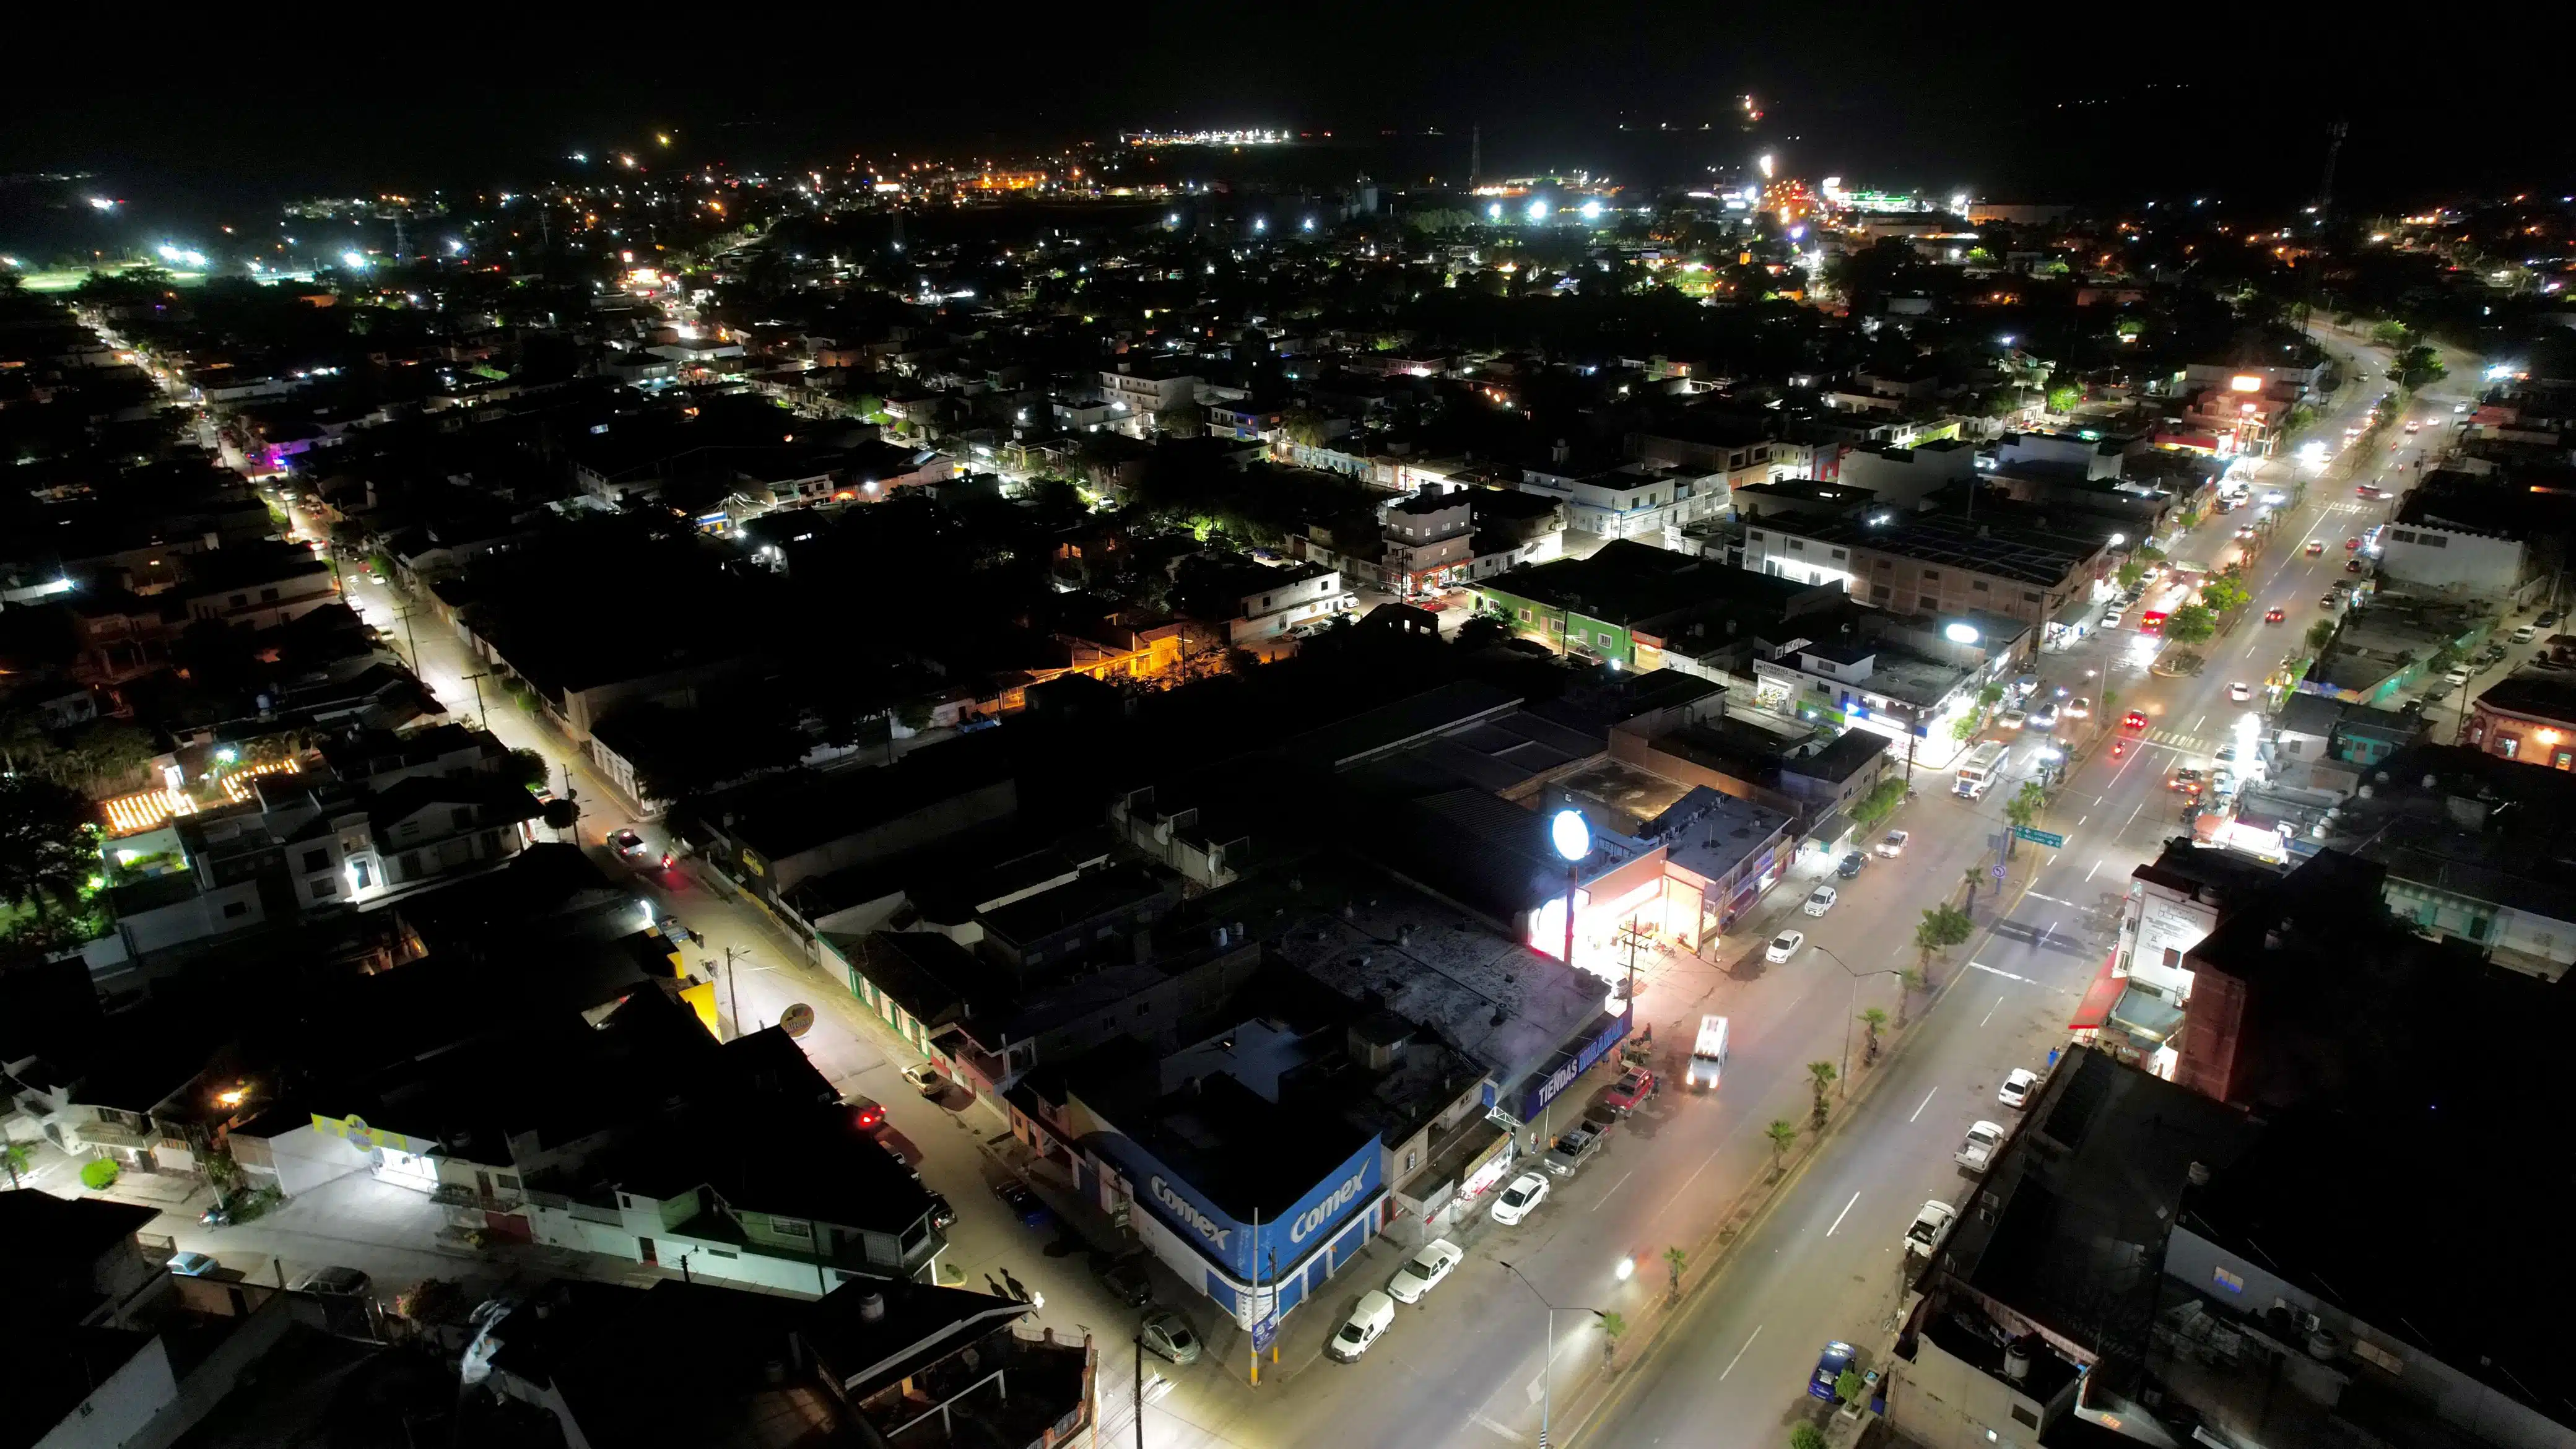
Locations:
0;2;2576;215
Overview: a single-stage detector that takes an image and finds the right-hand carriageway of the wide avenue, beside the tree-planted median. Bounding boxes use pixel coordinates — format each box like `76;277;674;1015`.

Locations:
1559;337;2465;1449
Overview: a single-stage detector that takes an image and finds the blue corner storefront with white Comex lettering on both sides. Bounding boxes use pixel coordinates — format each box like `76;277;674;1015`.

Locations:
1092;1132;1386;1328
